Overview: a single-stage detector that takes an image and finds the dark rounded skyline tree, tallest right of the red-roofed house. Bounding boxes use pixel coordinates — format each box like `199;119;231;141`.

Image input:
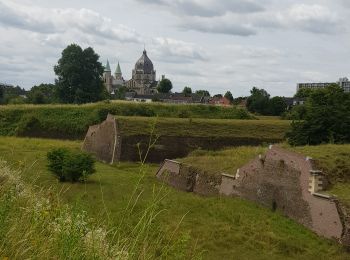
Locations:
247;87;270;115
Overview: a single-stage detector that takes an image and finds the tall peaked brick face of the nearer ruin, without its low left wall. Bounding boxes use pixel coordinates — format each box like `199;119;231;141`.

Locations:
220;147;344;243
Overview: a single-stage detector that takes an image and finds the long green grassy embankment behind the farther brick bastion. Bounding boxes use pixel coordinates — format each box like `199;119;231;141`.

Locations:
0;102;252;139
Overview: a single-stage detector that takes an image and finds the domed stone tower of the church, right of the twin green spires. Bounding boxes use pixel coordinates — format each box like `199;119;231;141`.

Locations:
128;50;157;94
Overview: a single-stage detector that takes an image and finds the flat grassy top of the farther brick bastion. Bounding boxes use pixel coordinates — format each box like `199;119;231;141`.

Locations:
116;116;290;140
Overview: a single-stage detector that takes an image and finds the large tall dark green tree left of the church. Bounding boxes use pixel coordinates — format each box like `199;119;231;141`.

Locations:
54;44;104;104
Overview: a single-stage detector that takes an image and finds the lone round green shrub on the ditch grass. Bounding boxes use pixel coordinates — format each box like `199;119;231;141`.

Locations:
47;148;95;182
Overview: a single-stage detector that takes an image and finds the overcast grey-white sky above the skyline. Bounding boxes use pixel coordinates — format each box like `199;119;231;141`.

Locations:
0;0;350;97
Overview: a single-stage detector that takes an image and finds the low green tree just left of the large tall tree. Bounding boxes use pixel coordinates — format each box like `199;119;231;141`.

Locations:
27;84;58;104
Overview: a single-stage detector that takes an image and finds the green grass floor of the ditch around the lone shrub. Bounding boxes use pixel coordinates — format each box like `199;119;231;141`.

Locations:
0;137;349;259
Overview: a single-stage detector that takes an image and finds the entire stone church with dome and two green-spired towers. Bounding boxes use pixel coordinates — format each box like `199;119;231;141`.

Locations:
103;50;158;95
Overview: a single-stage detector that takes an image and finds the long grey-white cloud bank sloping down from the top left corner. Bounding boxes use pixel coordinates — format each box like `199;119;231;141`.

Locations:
0;1;142;43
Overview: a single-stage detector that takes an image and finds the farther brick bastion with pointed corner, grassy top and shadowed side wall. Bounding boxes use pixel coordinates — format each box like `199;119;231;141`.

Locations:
82;114;288;163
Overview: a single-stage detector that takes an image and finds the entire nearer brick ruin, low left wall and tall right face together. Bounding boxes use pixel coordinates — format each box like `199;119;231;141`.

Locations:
156;146;350;245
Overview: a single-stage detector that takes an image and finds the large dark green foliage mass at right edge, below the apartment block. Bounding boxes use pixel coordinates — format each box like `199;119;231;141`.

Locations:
287;85;350;145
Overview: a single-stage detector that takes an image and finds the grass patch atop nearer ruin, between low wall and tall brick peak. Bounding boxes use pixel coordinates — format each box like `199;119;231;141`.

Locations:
178;146;267;175
